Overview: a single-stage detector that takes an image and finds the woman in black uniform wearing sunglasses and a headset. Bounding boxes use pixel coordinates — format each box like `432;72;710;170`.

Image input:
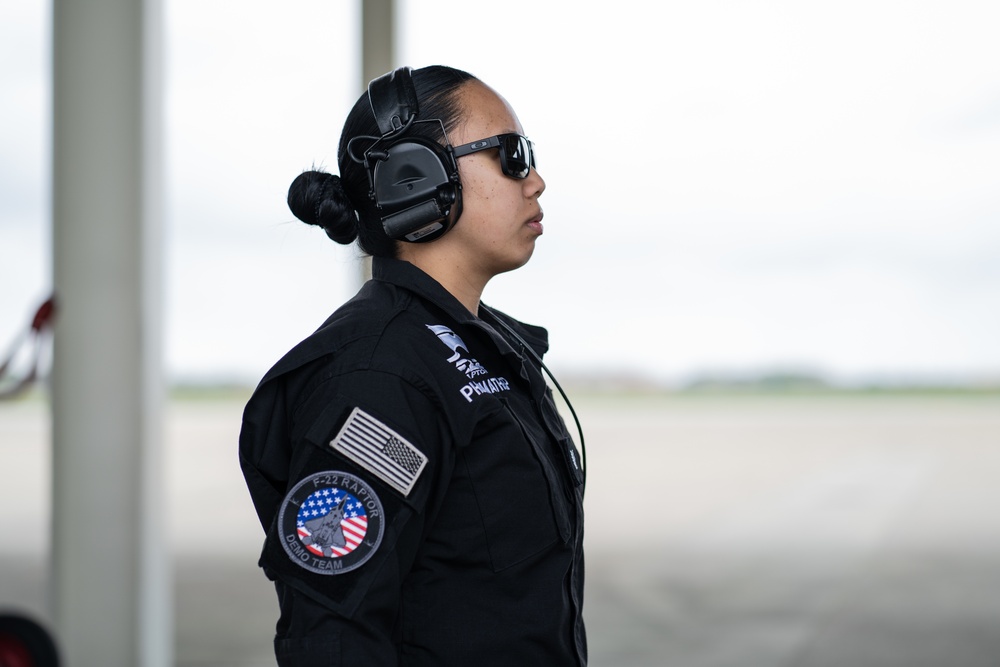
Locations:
240;67;587;667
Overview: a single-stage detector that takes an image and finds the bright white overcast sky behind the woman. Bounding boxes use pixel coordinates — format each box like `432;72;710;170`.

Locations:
0;0;1000;382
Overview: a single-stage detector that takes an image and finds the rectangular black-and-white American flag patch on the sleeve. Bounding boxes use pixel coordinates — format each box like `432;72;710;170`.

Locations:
330;408;427;496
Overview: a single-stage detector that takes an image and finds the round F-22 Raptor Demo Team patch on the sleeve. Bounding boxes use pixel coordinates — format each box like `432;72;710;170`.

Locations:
278;471;385;574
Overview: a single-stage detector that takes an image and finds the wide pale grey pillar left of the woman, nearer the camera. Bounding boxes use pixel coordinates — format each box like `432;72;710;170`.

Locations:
51;0;173;667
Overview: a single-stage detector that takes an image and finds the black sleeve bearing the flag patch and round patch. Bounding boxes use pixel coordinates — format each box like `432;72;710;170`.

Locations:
261;370;455;667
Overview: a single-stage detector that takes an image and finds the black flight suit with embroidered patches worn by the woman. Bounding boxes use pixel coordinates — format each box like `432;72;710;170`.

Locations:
240;258;587;667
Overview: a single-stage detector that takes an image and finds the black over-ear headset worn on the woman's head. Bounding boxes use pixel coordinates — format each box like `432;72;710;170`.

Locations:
361;67;462;243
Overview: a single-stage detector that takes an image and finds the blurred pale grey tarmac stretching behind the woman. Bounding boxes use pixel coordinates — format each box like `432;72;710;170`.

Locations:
0;394;1000;667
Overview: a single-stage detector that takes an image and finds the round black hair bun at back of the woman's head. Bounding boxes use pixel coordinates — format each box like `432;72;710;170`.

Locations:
288;171;358;245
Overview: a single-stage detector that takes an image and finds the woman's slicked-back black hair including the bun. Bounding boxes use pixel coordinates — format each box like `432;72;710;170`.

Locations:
288;65;476;257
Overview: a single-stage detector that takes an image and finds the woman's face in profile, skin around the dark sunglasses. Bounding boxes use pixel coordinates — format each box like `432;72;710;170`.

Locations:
439;81;545;280
